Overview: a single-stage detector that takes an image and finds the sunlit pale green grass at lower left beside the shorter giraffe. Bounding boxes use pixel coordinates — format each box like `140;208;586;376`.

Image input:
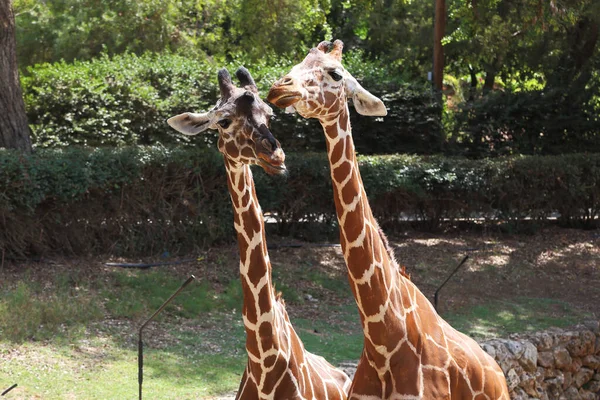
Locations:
0;318;245;399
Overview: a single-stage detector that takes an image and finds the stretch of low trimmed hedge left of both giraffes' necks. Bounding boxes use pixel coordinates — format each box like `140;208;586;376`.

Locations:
0;147;232;254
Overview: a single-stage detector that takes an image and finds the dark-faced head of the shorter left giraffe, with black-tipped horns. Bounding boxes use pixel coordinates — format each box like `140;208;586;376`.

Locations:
167;67;286;174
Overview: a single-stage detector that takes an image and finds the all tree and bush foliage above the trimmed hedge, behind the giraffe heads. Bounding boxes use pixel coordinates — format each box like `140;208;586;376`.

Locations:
15;0;600;157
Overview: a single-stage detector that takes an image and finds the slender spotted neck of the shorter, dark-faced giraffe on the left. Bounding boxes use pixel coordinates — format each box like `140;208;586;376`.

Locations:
225;159;277;363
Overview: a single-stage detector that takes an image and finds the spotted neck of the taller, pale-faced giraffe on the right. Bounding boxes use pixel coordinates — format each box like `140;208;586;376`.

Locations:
320;105;414;338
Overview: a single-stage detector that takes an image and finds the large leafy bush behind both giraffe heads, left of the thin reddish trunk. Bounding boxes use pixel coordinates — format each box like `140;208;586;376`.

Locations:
22;52;441;154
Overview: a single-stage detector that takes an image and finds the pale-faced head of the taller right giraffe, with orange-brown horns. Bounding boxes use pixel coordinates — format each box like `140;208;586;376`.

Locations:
267;40;387;119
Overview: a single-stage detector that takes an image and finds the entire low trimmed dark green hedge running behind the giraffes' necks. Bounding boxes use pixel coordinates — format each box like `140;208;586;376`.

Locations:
0;146;600;255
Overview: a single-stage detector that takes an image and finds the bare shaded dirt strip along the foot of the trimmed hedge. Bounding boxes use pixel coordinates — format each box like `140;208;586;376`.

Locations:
0;227;600;324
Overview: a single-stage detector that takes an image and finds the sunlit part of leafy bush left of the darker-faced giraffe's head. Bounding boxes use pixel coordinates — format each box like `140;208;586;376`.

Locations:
22;54;223;147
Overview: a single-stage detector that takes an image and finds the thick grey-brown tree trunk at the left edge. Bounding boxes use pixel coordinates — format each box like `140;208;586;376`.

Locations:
0;0;31;152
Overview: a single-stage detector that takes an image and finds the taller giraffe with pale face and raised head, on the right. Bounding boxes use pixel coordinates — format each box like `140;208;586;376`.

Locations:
267;40;509;400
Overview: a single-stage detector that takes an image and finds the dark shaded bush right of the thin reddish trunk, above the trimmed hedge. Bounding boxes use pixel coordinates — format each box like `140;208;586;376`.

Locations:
453;87;600;157
